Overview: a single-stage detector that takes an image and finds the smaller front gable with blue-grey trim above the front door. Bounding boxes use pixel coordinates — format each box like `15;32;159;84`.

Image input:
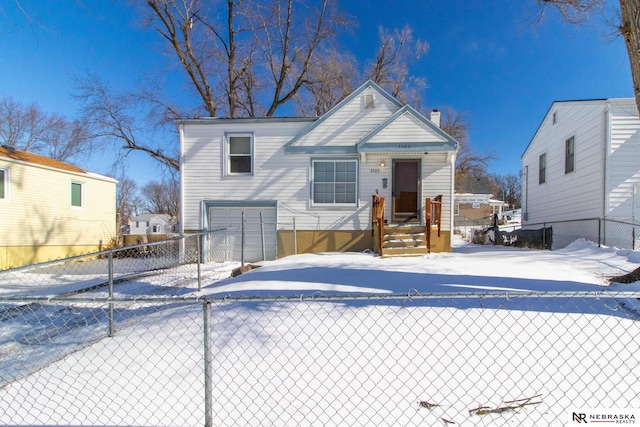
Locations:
357;105;458;152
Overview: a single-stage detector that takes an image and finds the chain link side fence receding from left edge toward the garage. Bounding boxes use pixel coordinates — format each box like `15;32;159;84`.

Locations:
0;230;240;296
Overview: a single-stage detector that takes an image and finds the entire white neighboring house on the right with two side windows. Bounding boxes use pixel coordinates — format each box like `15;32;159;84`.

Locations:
522;98;640;247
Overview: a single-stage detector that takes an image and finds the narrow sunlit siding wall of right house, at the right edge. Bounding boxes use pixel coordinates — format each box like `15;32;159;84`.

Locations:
606;99;640;220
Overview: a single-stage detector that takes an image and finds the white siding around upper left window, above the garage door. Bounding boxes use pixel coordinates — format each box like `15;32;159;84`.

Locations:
181;121;309;230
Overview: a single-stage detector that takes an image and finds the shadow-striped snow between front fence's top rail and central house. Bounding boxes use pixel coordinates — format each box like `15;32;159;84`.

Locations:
206;238;640;295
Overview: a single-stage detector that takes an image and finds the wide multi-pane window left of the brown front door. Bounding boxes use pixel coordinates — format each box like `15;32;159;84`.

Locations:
311;160;358;206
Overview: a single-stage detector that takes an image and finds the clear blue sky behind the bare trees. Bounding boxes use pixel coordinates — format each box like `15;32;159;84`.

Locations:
0;0;633;184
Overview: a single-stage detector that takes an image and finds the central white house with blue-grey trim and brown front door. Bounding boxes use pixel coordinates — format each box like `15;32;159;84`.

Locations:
179;82;458;260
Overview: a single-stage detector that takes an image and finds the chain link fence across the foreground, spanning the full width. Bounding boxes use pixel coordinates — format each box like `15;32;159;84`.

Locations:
0;290;640;426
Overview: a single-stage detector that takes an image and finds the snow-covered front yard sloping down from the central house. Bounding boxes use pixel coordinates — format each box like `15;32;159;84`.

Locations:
0;241;640;426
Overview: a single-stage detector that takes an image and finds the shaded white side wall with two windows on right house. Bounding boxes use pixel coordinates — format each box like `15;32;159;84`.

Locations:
522;101;605;224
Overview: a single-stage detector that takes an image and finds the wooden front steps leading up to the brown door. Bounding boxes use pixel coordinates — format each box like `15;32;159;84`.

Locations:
380;224;428;257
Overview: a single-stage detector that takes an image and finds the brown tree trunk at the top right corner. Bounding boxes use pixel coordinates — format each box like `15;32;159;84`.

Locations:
619;0;640;112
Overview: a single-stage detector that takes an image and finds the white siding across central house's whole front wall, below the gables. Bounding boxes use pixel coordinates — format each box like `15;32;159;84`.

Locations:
181;122;453;234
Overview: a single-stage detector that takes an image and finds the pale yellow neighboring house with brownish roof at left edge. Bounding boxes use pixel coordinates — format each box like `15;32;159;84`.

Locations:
0;146;117;269
